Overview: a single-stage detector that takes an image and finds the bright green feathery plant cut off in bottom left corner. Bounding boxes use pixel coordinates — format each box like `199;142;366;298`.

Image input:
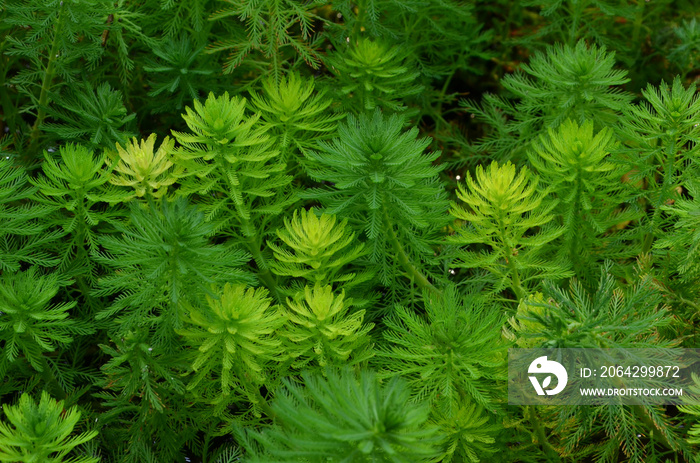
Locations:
0;391;100;463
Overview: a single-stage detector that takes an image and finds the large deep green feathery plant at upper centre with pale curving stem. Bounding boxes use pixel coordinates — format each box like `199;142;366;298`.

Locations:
304;110;448;286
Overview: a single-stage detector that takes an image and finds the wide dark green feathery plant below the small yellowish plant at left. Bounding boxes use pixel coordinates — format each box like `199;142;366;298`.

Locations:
95;198;255;347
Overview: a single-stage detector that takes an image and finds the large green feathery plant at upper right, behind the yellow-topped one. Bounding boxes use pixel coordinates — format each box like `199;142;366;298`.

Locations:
461;41;632;161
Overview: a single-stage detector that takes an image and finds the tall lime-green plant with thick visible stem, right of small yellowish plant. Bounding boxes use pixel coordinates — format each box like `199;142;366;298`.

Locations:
173;92;292;236
